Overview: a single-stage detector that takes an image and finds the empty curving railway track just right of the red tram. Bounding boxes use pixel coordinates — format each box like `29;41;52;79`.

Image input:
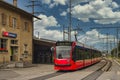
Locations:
81;60;112;80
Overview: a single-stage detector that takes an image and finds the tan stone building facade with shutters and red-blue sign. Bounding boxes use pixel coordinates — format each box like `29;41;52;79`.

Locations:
0;0;33;63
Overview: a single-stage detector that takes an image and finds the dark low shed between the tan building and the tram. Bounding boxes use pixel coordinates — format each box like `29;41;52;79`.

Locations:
33;38;56;64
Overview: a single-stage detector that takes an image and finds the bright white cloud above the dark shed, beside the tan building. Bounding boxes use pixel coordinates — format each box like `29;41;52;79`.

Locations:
34;14;63;40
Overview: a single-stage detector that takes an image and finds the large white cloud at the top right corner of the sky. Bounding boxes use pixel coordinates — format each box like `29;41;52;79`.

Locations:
72;0;120;24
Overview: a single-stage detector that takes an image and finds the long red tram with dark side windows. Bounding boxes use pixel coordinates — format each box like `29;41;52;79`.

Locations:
54;41;101;70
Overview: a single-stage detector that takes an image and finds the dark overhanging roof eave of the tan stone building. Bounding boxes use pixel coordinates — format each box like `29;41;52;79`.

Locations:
0;0;41;20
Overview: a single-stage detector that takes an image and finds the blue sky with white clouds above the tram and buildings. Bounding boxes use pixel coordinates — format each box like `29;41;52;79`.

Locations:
5;0;120;50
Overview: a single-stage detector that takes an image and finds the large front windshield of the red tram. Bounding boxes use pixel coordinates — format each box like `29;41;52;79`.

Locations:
56;46;71;59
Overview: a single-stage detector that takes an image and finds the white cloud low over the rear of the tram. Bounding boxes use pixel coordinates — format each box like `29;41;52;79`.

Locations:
78;29;115;48
